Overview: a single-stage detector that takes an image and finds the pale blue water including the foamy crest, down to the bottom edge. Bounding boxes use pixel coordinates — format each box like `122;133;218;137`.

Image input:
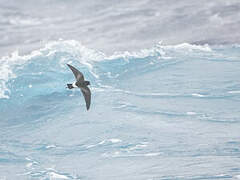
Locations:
0;40;240;180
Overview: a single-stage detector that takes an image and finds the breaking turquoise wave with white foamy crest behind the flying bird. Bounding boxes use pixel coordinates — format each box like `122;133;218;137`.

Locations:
0;40;238;101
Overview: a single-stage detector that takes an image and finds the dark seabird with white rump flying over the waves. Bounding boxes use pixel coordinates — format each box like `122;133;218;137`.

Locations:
67;64;91;110
